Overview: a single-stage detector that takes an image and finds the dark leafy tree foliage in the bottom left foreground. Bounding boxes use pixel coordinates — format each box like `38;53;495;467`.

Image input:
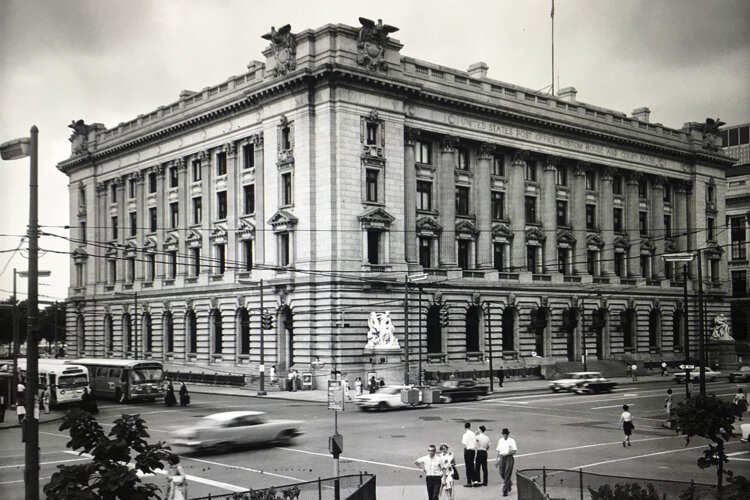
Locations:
44;408;179;500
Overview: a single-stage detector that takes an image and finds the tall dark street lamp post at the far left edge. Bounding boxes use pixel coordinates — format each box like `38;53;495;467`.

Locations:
0;125;39;500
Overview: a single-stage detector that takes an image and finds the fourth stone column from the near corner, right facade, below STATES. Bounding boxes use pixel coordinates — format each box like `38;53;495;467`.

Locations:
507;150;529;272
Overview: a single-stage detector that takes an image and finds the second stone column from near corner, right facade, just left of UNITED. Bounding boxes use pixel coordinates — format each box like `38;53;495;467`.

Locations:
438;136;458;267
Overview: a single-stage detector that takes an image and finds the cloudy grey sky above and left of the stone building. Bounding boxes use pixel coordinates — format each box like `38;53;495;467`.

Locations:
0;0;750;300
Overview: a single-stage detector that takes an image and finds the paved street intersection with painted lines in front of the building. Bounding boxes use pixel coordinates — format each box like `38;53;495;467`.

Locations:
0;383;750;500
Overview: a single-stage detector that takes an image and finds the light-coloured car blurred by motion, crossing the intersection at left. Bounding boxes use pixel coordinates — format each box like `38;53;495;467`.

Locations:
170;411;303;451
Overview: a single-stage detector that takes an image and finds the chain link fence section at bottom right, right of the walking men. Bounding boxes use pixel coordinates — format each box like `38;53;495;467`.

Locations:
516;468;717;500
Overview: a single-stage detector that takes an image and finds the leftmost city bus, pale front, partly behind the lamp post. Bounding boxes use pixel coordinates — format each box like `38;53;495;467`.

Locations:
18;358;89;407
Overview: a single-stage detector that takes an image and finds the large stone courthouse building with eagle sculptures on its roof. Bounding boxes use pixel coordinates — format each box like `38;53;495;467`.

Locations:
58;18;732;382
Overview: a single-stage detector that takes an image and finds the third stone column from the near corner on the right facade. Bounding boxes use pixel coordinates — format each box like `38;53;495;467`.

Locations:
474;143;493;269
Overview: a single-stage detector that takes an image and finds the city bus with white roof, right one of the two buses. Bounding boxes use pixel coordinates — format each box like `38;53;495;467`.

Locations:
66;358;164;403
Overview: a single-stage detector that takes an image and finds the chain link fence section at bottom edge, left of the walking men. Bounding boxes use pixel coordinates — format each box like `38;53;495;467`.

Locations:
191;474;375;500
